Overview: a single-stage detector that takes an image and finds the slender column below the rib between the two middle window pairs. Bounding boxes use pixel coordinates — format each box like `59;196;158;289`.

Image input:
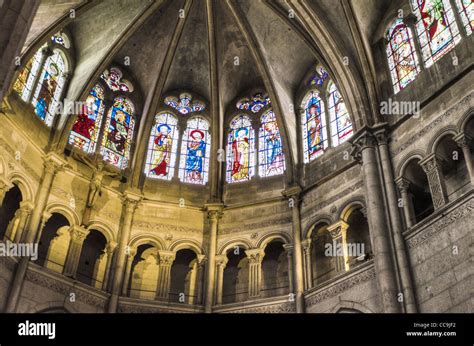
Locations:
204;203;223;313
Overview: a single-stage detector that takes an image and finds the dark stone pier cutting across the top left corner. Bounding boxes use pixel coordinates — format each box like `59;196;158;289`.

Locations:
0;0;41;102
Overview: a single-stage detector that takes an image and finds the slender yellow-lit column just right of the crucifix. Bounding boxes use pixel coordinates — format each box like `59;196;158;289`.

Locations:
107;192;141;313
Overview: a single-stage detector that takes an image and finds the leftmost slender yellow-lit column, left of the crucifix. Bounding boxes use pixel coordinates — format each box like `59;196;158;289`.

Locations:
5;153;66;312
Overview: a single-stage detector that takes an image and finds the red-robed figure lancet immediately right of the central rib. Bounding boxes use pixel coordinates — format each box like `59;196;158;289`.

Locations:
226;114;255;183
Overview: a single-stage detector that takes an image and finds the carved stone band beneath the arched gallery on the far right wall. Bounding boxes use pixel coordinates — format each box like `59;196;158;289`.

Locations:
407;198;474;248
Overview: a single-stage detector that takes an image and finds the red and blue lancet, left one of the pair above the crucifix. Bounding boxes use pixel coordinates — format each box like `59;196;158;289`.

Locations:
69;84;105;153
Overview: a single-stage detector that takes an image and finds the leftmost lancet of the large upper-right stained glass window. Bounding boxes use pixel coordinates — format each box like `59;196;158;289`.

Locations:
387;19;420;94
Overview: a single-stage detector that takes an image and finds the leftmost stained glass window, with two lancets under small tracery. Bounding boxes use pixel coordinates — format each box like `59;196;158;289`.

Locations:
13;32;71;126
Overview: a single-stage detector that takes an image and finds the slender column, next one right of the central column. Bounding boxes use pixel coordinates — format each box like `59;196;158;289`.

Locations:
283;186;305;313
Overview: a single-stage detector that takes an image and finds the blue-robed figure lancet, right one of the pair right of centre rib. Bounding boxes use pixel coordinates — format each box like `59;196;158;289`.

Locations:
258;110;285;177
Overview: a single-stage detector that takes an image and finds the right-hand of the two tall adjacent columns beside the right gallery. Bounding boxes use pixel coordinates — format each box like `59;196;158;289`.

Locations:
376;126;417;313
